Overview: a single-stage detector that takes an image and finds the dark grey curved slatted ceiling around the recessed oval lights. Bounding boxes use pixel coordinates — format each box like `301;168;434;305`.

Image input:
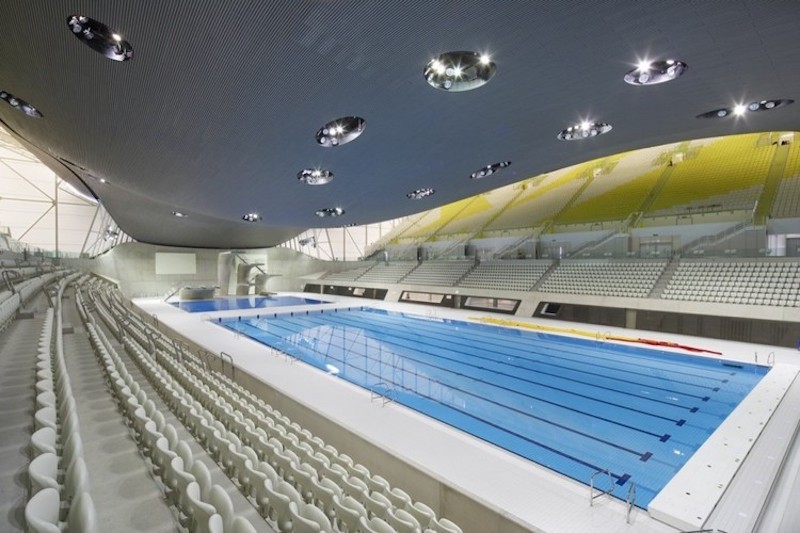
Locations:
0;0;800;247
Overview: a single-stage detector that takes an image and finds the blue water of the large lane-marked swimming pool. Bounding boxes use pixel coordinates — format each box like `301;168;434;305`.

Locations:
222;309;767;508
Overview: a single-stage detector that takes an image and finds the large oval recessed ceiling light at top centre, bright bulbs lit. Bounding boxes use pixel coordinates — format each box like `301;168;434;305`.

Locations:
422;52;497;92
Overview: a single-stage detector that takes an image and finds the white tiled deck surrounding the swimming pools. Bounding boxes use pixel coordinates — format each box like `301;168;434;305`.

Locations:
134;293;800;532
